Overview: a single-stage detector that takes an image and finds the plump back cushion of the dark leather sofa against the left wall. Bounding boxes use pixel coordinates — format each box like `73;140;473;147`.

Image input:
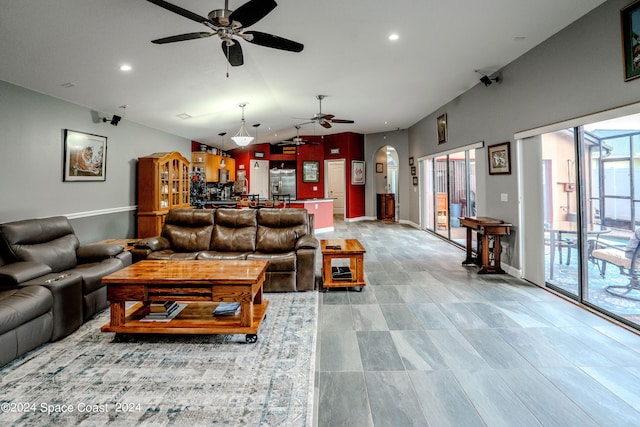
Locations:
0;216;80;273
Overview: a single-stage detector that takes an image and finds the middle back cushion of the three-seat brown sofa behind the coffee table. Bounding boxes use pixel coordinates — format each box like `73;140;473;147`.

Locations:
211;209;257;252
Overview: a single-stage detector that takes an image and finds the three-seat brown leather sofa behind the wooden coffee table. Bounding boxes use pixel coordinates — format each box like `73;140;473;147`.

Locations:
132;208;318;292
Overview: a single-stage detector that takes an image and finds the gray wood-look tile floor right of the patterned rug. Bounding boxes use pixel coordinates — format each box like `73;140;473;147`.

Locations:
314;221;640;427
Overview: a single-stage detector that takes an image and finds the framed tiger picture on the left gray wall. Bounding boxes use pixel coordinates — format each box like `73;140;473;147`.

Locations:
62;129;107;181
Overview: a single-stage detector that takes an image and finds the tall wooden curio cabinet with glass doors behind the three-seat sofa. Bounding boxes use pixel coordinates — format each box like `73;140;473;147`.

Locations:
138;151;191;238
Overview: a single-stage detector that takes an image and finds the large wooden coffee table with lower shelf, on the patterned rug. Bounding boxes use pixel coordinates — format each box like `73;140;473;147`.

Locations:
101;260;269;342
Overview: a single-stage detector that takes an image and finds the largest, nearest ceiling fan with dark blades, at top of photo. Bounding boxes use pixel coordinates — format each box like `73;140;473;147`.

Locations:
147;0;304;66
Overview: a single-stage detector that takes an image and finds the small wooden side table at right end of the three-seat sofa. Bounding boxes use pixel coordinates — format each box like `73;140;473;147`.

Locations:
320;239;367;291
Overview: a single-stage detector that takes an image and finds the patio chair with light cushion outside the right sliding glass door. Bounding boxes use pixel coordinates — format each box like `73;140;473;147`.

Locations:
591;228;640;301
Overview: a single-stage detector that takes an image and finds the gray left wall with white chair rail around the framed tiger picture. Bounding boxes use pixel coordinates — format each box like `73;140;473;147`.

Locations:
0;81;191;242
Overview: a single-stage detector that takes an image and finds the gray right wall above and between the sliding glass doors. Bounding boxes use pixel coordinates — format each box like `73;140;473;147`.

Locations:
408;0;640;268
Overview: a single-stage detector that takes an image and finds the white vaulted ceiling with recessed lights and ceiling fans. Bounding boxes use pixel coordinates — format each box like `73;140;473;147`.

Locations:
0;0;604;148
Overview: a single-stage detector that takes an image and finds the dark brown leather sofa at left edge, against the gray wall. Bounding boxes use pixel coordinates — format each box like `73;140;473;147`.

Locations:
0;216;132;366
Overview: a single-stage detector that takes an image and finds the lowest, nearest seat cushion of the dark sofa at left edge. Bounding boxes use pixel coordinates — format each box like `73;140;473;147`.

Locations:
0;286;53;334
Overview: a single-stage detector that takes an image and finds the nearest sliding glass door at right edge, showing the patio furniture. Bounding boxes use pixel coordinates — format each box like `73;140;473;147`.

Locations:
541;116;640;327
